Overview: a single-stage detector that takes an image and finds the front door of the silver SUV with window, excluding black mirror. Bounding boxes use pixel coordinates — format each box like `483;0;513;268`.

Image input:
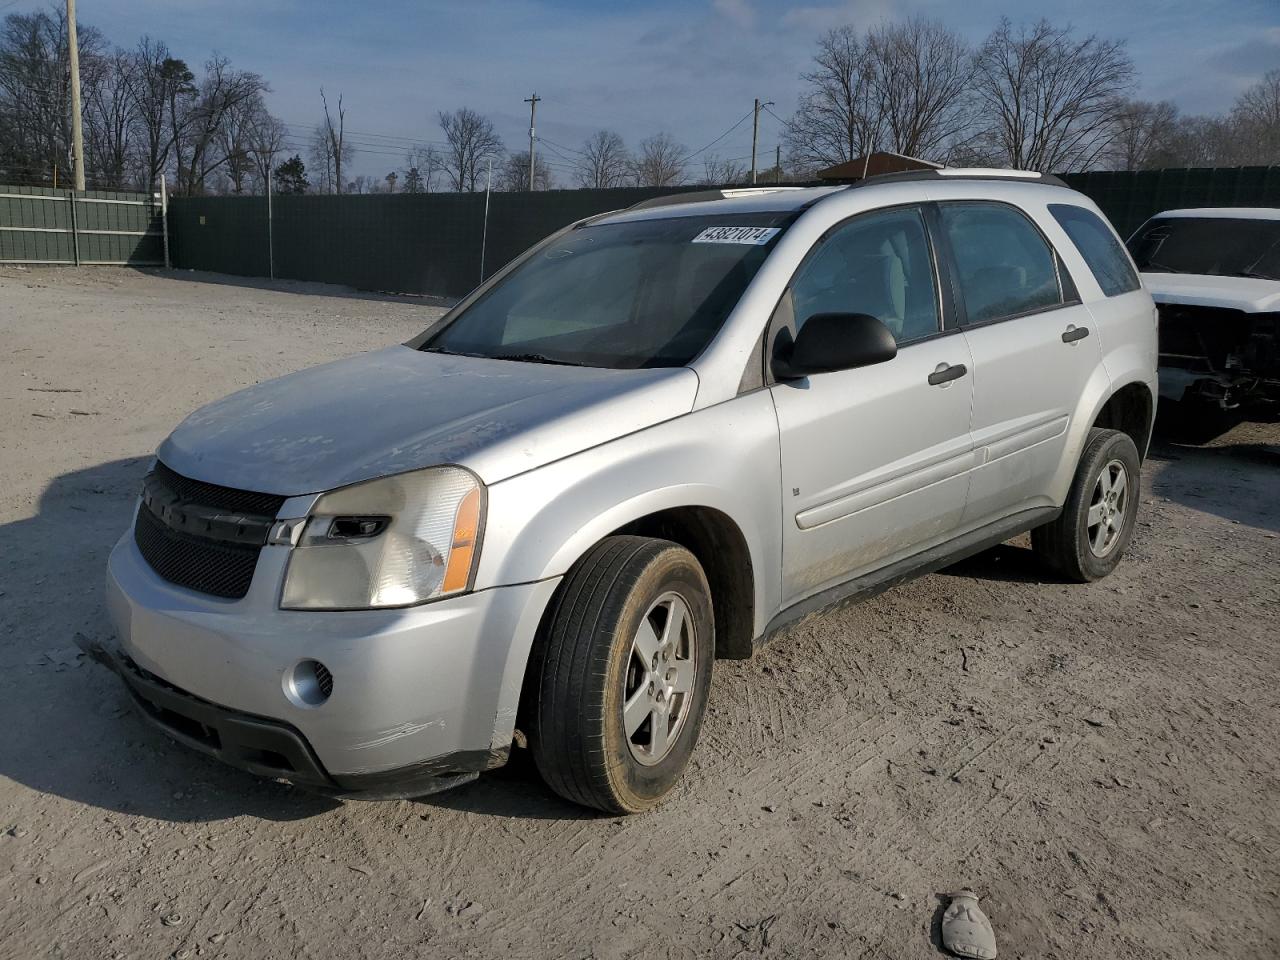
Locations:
772;206;973;604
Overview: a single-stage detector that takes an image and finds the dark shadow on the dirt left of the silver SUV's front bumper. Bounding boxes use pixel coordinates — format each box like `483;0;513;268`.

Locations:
0;457;338;823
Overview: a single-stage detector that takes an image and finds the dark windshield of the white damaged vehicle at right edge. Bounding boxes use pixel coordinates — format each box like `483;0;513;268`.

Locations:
1129;216;1280;280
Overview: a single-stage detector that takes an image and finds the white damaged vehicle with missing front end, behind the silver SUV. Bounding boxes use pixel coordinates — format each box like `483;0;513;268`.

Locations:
1129;207;1280;436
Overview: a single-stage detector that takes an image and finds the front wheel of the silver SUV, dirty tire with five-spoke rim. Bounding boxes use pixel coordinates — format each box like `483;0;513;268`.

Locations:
526;536;716;814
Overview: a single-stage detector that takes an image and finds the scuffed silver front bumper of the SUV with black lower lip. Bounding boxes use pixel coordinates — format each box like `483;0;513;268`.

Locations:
92;535;557;796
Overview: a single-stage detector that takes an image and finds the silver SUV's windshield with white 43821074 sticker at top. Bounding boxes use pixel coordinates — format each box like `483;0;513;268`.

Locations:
420;212;791;369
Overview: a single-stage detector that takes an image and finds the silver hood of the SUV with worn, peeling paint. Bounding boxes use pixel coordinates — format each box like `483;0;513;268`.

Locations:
159;346;698;497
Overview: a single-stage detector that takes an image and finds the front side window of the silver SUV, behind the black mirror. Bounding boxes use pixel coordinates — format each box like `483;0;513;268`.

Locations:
791;207;938;343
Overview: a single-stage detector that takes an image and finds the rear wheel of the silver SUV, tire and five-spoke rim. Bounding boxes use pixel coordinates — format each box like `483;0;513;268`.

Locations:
1032;428;1142;584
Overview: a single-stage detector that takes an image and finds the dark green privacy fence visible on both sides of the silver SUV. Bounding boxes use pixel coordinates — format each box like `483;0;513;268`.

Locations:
160;166;1280;297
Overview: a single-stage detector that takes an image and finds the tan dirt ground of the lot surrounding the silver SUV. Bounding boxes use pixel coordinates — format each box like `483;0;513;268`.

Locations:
0;268;1280;960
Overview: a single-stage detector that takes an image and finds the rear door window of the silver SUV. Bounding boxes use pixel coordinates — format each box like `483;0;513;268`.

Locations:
941;201;1062;324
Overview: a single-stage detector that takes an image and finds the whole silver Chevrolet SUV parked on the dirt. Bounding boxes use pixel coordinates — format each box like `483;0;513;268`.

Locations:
82;170;1156;813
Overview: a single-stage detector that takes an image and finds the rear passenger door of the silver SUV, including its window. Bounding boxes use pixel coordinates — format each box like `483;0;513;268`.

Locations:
938;200;1102;527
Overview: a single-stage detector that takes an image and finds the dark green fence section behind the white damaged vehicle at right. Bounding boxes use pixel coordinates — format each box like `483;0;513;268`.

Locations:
1061;166;1280;238
